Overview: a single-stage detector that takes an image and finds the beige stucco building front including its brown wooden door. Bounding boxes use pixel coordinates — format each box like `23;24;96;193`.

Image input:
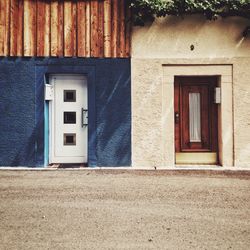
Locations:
131;15;250;168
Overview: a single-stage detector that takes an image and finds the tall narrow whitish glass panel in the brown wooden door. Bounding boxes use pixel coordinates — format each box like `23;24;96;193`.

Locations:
189;93;201;142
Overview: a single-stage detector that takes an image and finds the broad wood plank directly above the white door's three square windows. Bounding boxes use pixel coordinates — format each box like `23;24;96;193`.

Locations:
64;1;76;57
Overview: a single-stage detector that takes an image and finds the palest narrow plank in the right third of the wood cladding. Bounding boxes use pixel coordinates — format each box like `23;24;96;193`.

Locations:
103;0;111;57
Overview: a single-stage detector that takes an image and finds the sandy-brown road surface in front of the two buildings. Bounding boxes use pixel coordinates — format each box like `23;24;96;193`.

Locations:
0;170;250;250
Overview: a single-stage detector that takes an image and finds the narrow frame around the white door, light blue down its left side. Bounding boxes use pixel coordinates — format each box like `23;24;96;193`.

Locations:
49;74;89;164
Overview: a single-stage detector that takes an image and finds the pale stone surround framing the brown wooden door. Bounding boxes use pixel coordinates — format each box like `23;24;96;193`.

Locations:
162;64;234;167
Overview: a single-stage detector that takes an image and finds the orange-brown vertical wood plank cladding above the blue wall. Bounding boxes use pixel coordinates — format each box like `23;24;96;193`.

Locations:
0;0;131;58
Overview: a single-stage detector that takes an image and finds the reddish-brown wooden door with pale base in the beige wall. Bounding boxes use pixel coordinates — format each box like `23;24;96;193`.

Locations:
175;77;218;164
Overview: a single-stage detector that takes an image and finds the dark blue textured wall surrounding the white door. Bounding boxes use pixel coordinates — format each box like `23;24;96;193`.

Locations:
0;58;131;167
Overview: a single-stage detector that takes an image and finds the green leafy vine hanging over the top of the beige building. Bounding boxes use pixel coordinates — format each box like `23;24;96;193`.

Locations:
129;0;250;25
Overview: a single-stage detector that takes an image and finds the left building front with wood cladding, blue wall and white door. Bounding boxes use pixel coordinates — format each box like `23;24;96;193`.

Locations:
0;0;131;167
